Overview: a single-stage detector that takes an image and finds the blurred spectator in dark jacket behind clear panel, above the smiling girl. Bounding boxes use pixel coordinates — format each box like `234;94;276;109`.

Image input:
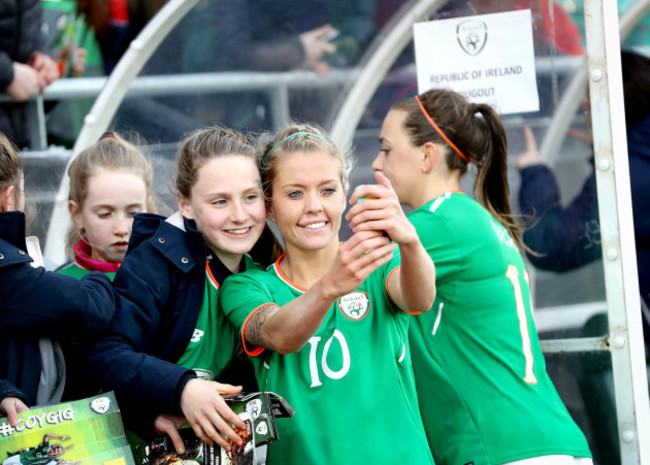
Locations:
89;0;346;142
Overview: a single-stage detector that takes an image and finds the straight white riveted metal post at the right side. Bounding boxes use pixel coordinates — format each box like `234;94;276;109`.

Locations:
585;0;650;464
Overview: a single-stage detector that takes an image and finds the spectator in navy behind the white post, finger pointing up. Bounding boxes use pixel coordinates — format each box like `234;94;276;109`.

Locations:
517;52;650;318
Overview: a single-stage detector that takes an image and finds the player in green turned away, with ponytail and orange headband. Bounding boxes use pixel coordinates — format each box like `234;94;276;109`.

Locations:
373;90;591;465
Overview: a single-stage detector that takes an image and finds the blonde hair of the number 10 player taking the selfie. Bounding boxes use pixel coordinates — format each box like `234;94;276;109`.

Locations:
260;123;354;197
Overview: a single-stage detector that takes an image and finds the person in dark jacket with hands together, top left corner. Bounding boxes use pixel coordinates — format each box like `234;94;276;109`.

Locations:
0;0;59;147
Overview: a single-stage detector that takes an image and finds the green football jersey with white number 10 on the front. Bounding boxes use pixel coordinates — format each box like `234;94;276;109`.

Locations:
221;260;433;465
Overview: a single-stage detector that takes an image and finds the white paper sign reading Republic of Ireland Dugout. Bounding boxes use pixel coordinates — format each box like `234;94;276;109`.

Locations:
413;10;539;114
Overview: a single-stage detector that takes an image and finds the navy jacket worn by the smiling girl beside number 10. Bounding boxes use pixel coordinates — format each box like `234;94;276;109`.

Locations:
90;213;206;434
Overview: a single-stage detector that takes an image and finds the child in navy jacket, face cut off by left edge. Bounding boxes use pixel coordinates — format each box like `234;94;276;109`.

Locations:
0;134;115;412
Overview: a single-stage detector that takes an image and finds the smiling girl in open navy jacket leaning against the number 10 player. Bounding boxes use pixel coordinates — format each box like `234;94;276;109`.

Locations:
91;128;278;452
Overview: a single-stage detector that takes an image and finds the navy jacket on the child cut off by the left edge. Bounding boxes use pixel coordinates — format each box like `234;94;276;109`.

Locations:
0;211;115;405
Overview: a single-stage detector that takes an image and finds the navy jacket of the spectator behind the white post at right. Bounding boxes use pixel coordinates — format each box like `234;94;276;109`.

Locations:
519;116;650;320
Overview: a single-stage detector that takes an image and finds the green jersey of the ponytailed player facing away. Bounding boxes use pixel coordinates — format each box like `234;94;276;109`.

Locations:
409;193;591;465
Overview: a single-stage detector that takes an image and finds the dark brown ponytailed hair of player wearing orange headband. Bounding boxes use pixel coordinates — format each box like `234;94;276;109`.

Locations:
393;89;524;250
